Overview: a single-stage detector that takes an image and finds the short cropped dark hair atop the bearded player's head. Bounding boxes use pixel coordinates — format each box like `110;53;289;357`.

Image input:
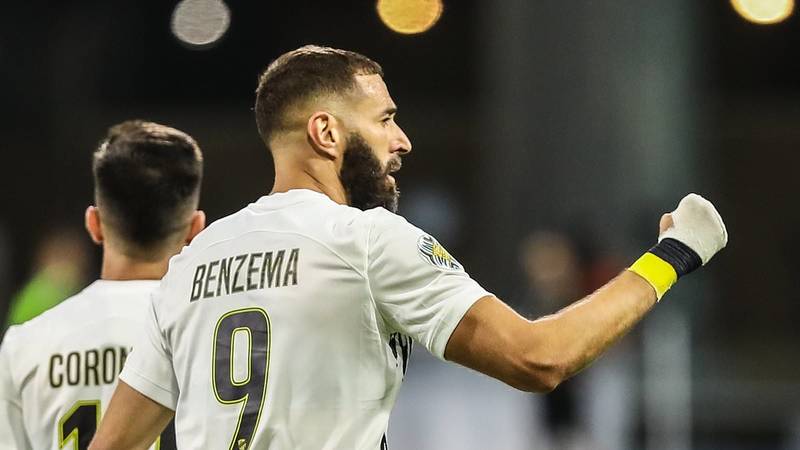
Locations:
255;45;383;145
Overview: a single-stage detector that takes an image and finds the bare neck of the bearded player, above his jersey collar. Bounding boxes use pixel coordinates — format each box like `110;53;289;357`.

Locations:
271;155;348;205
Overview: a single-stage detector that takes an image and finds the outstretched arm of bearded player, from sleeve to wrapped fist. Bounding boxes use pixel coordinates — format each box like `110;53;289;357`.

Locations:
444;194;728;392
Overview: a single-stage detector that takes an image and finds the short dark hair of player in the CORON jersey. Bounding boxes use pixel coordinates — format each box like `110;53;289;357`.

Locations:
92;120;203;259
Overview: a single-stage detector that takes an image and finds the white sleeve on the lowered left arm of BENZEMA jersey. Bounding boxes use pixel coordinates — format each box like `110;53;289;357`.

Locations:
119;291;179;411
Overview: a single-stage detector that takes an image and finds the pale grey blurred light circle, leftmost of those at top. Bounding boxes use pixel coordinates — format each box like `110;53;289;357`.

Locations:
172;0;231;47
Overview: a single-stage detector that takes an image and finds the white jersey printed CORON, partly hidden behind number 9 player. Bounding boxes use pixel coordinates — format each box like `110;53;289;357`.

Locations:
0;280;174;450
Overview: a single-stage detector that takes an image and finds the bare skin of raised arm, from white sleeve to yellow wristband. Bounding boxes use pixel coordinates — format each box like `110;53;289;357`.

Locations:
445;271;656;392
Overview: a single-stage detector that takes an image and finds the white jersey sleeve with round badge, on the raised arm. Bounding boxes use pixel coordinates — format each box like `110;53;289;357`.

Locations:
367;210;491;359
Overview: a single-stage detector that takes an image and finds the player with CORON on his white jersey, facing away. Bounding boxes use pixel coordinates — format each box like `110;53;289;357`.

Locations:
0;121;205;450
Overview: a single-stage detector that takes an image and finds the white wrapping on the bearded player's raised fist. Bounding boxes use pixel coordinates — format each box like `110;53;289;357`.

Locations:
658;194;728;265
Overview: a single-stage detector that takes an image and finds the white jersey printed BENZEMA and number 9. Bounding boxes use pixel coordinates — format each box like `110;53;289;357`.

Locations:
120;190;489;450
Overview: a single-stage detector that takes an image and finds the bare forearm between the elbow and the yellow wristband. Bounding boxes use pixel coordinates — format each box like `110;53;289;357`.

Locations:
520;271;656;379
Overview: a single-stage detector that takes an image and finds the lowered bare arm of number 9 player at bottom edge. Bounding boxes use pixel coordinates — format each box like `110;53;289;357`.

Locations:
89;380;175;450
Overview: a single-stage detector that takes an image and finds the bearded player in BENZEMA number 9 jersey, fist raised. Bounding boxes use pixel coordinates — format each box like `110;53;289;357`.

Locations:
92;46;727;450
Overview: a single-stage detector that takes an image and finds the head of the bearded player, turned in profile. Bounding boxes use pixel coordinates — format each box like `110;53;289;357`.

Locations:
255;46;411;210
